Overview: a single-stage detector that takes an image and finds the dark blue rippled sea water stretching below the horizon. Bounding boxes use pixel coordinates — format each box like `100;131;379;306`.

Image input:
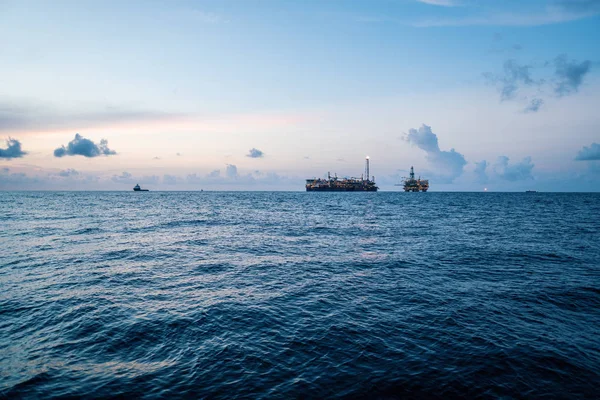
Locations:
0;192;600;399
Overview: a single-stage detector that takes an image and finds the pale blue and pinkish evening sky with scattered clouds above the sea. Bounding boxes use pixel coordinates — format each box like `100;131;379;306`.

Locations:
0;0;600;192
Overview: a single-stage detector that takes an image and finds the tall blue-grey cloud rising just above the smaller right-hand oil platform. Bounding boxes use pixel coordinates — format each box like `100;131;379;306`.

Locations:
403;124;467;183
